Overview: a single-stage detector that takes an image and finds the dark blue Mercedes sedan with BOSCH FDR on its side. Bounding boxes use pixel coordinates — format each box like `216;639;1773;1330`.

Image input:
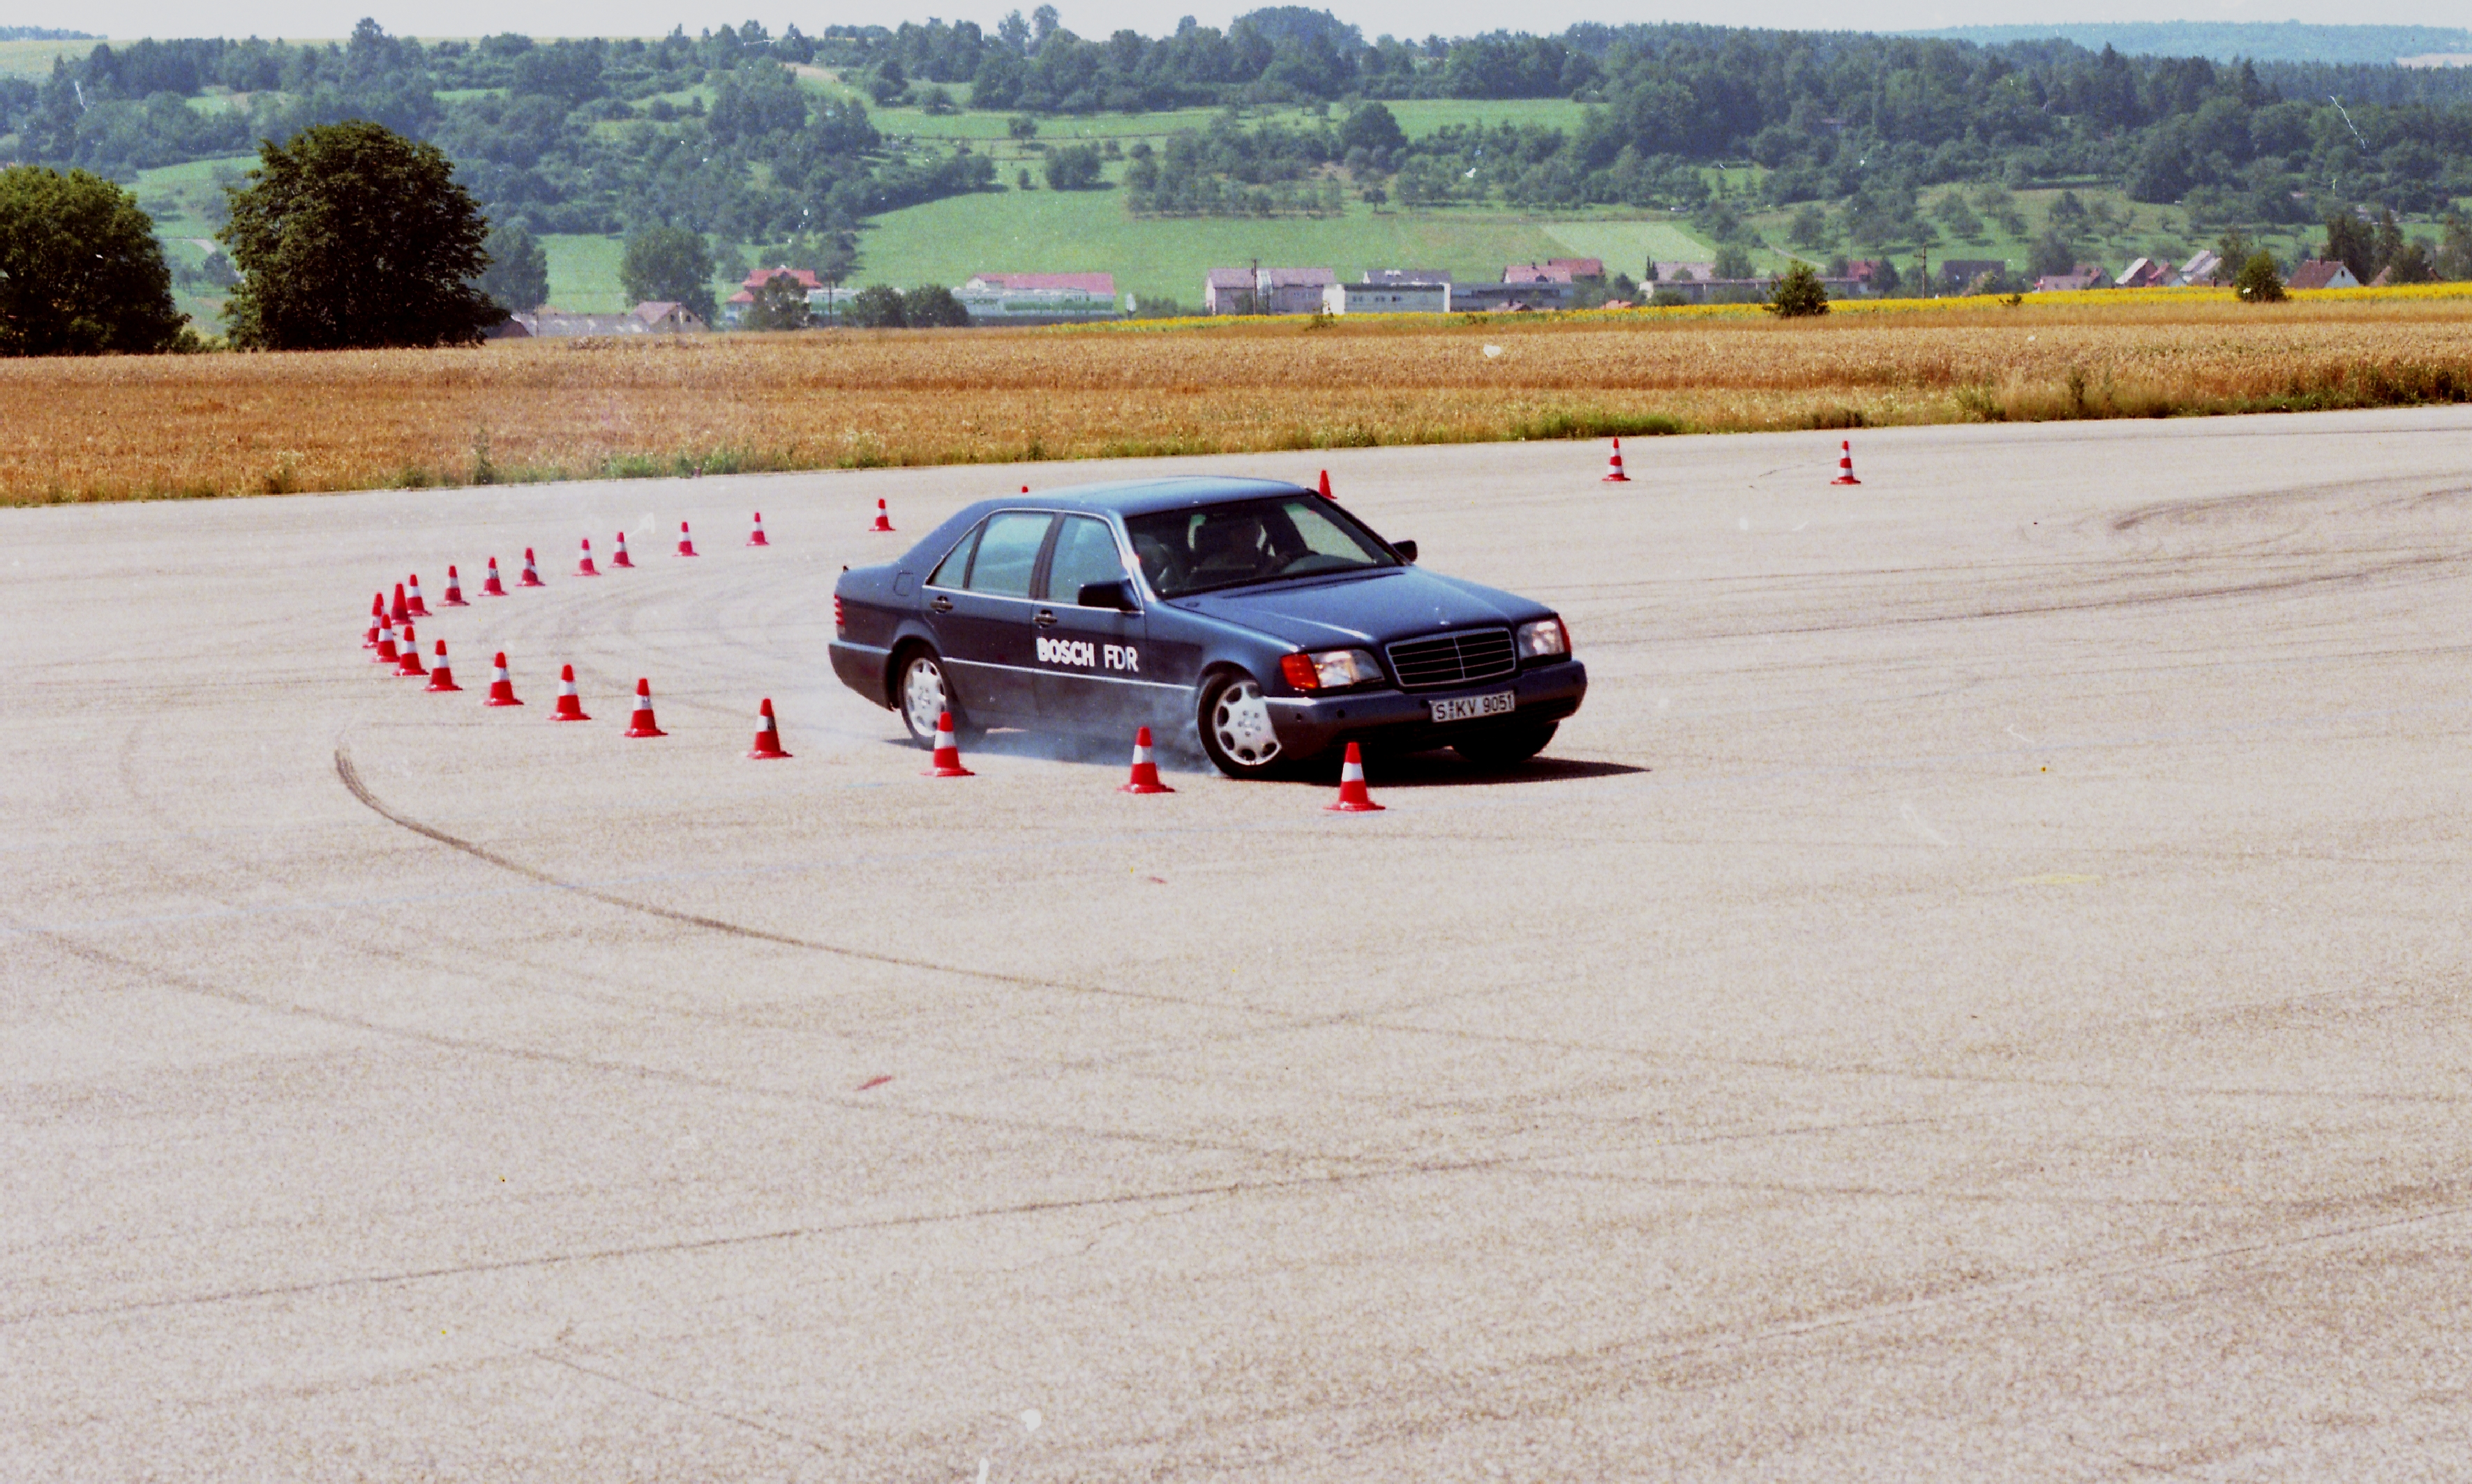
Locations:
833;477;1587;779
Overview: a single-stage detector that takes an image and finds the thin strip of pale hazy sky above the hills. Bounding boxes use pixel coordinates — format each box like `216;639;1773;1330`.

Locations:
33;0;2467;37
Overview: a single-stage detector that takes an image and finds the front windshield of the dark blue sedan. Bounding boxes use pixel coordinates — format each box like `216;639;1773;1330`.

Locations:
1125;495;1399;599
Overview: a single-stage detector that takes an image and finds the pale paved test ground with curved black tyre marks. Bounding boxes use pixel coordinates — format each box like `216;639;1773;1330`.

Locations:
0;410;2472;1481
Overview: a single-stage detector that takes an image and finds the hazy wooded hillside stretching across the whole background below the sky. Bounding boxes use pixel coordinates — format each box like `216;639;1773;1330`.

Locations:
0;5;2472;262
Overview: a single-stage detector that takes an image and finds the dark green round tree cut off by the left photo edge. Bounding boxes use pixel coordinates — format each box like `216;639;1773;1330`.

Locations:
0;166;188;356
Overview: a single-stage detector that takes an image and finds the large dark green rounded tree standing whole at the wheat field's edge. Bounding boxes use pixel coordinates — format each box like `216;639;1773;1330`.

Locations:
215;119;502;351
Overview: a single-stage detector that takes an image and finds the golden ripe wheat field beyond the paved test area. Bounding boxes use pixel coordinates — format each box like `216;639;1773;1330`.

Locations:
0;294;2472;504
